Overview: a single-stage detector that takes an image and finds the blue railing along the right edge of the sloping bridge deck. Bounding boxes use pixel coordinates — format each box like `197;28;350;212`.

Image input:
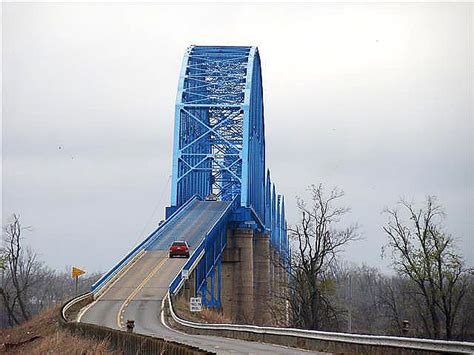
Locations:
169;197;238;294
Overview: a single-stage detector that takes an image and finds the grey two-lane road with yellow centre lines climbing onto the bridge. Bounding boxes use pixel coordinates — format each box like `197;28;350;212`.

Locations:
79;202;330;354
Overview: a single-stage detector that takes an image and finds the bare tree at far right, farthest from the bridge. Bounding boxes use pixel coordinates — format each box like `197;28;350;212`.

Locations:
382;196;468;339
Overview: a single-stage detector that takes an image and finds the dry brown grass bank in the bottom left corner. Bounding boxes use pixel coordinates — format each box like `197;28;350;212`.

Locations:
0;308;112;354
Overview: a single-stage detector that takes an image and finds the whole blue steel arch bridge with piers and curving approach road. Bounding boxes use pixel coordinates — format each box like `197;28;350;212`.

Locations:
65;46;474;354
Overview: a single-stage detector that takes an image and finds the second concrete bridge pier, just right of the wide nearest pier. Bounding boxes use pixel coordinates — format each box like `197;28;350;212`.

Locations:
254;234;270;325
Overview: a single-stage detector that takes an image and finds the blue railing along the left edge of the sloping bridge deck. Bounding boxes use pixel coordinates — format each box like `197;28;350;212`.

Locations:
91;195;198;293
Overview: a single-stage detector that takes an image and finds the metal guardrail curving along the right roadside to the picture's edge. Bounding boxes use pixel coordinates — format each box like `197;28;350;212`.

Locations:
167;293;474;354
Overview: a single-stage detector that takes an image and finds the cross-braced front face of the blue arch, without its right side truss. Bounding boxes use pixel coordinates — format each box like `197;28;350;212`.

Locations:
172;47;253;210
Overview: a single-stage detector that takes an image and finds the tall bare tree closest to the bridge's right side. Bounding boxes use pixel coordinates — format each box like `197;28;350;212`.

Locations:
287;185;359;329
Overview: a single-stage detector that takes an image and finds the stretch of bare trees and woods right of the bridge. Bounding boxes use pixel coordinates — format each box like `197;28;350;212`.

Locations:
279;185;474;340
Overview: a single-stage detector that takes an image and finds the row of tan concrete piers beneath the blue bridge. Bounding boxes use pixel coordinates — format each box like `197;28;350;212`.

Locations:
221;228;288;325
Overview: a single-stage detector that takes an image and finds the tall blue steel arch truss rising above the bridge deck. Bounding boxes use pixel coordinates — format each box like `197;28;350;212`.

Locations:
171;46;265;220
